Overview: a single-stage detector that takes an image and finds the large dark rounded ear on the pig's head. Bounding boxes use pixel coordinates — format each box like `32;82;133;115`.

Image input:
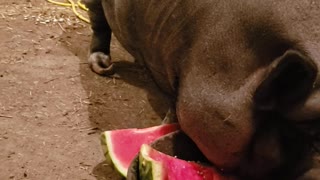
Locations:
253;50;318;110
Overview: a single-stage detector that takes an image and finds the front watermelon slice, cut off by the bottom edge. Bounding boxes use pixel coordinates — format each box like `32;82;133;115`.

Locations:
139;144;235;180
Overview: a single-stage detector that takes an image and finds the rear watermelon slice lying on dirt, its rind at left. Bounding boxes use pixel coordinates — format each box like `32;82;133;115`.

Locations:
101;124;179;177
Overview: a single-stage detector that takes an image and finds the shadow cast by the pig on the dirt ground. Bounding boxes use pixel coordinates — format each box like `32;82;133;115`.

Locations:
61;27;170;180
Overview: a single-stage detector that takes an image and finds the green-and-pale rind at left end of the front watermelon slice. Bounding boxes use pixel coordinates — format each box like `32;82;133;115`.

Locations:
139;144;165;180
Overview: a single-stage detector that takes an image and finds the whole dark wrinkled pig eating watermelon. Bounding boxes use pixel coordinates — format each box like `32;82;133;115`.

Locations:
85;0;320;179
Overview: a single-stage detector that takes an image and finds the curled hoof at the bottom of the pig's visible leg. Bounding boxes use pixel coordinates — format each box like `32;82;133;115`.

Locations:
88;52;114;76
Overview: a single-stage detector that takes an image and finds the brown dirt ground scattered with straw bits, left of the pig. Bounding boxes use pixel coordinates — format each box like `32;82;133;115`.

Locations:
0;0;169;180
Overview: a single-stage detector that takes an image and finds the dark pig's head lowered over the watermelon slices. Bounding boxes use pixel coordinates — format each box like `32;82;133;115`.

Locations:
177;16;320;179
